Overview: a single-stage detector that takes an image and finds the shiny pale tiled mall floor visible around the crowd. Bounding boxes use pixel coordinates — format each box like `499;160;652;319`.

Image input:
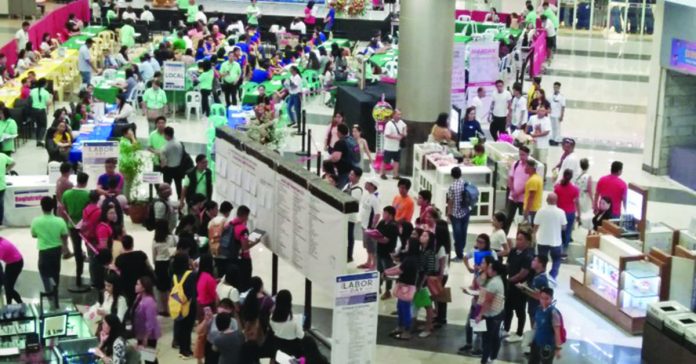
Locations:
0;4;696;364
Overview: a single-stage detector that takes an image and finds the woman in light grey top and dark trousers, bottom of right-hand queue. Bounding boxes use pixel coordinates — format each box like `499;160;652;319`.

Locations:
475;261;507;363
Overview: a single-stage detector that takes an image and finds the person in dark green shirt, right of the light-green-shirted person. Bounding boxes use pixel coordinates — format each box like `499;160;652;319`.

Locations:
61;172;89;287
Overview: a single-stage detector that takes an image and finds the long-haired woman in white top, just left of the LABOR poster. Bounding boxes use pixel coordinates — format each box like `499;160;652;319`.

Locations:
270;289;304;357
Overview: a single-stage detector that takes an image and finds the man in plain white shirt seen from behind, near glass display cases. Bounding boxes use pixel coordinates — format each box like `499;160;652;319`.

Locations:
534;192;573;279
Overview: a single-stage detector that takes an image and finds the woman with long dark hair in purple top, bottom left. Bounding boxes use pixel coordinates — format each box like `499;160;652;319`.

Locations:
132;276;162;363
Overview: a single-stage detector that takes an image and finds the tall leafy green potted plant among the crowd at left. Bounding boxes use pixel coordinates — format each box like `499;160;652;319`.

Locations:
118;138;147;224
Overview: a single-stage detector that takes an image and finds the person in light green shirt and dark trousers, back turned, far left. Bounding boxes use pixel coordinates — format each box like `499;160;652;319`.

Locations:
31;196;68;301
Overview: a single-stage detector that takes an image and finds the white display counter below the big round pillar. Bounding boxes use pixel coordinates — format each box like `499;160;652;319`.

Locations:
413;143;493;221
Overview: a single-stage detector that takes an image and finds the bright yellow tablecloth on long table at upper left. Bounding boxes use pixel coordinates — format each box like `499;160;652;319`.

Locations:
0;49;77;107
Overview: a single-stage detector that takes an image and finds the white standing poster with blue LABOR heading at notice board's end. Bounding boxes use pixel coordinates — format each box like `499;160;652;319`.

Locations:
331;272;379;364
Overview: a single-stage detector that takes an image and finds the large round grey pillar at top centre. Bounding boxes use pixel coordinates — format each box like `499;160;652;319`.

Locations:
396;0;455;175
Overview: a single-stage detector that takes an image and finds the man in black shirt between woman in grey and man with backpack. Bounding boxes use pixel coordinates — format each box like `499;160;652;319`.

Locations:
503;231;534;343
